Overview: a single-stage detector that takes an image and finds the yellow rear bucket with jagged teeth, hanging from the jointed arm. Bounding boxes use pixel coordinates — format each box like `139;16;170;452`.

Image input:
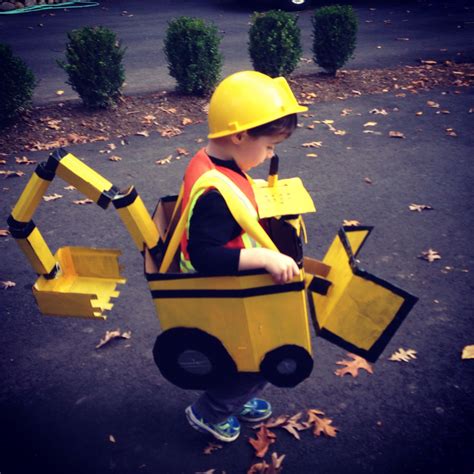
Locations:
33;247;126;319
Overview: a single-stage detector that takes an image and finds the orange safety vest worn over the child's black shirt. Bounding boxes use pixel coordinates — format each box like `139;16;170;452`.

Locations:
180;148;261;273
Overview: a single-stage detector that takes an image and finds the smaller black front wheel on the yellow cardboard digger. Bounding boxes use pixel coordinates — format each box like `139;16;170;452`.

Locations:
260;344;313;387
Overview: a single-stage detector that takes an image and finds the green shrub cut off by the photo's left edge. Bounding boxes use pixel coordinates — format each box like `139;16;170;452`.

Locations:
0;44;36;128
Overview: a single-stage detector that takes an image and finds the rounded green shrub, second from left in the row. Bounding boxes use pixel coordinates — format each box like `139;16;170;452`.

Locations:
58;26;125;108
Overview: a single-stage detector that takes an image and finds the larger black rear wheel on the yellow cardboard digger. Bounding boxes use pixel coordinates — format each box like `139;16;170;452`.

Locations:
153;328;237;390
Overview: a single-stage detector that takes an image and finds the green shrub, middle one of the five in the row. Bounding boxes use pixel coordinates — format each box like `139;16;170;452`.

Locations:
164;16;222;95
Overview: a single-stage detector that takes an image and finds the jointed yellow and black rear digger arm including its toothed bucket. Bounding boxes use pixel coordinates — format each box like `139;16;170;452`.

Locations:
8;148;160;319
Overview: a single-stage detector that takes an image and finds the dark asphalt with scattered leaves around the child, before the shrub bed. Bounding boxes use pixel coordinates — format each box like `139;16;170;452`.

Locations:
0;2;474;474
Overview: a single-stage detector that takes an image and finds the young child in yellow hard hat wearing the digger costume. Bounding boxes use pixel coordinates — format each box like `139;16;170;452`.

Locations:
181;71;307;442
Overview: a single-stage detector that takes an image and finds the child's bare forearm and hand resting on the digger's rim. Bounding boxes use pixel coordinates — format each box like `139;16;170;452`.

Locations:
239;248;300;283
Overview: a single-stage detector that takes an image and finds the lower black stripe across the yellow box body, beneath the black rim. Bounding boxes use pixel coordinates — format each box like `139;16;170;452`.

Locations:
151;281;304;299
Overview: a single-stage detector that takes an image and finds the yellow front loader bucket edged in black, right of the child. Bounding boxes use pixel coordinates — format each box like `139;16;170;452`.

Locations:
308;226;417;362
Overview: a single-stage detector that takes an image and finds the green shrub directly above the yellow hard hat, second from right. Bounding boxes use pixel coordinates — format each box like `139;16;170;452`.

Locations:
249;10;302;77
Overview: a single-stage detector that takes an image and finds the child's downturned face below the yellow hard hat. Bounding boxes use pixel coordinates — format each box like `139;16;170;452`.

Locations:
233;132;287;171
